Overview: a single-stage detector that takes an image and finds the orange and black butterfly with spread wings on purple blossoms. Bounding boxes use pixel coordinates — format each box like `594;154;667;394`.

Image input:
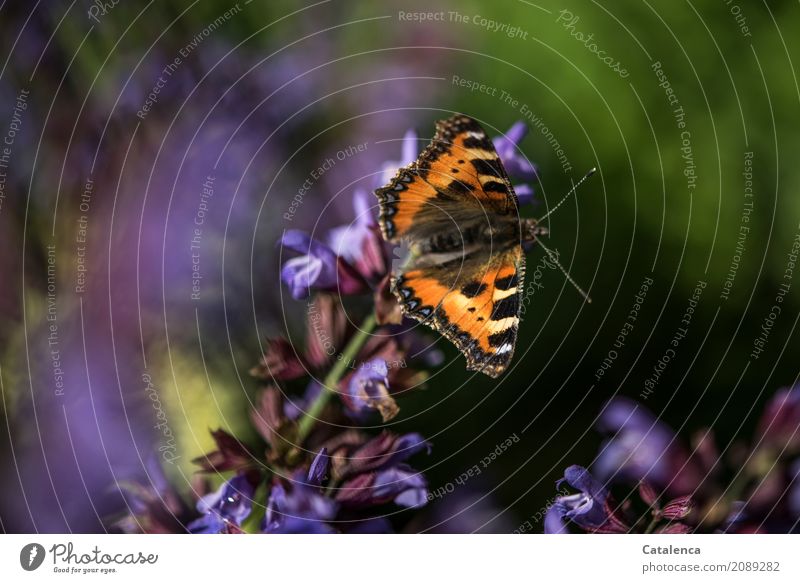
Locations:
375;115;547;377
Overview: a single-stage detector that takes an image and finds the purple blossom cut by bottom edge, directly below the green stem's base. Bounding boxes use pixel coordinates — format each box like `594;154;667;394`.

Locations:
263;482;337;534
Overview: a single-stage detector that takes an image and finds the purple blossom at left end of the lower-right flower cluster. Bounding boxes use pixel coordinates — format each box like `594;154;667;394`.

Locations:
544;465;609;534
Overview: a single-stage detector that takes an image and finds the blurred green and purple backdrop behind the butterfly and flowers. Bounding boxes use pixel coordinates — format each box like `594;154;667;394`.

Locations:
0;0;800;531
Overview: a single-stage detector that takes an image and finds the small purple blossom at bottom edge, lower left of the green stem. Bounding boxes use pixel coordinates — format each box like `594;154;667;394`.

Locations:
188;474;255;534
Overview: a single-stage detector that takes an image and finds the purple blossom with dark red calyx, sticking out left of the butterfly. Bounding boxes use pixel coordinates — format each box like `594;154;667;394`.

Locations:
280;229;366;300
